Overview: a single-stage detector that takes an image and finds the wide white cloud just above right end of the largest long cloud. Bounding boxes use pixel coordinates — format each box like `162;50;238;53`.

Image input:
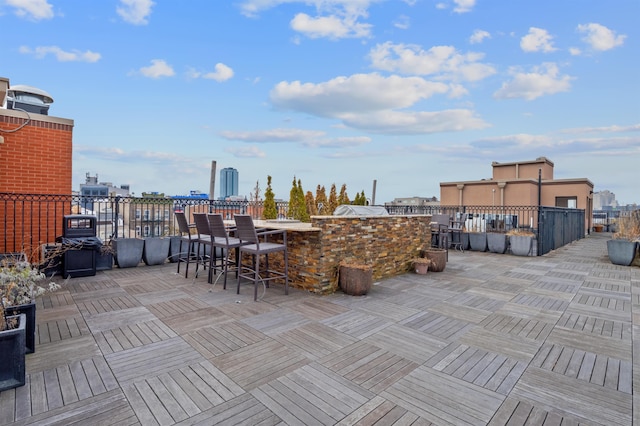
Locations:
369;42;495;81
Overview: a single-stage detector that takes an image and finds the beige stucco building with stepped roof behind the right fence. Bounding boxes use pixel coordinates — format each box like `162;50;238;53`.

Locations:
440;157;593;229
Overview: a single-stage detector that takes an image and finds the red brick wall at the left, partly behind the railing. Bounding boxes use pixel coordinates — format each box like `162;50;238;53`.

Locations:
0;109;73;257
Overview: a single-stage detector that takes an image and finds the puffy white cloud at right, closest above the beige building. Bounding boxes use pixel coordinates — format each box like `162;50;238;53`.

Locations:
493;63;574;101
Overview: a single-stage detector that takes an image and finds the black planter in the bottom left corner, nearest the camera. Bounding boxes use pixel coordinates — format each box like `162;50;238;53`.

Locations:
0;314;27;392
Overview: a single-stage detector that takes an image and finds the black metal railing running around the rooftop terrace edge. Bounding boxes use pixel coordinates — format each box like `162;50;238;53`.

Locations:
0;193;585;259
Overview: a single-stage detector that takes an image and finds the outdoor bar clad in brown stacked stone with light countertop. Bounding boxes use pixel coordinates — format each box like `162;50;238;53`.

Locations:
255;215;431;294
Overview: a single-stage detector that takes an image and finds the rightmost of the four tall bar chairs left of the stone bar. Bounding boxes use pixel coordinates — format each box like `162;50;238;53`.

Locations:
234;215;289;300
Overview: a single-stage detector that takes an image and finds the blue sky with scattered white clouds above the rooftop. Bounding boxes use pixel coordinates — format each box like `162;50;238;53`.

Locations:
0;0;640;204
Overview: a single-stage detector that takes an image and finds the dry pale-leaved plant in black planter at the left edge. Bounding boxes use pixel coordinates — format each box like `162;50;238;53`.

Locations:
0;257;60;353
